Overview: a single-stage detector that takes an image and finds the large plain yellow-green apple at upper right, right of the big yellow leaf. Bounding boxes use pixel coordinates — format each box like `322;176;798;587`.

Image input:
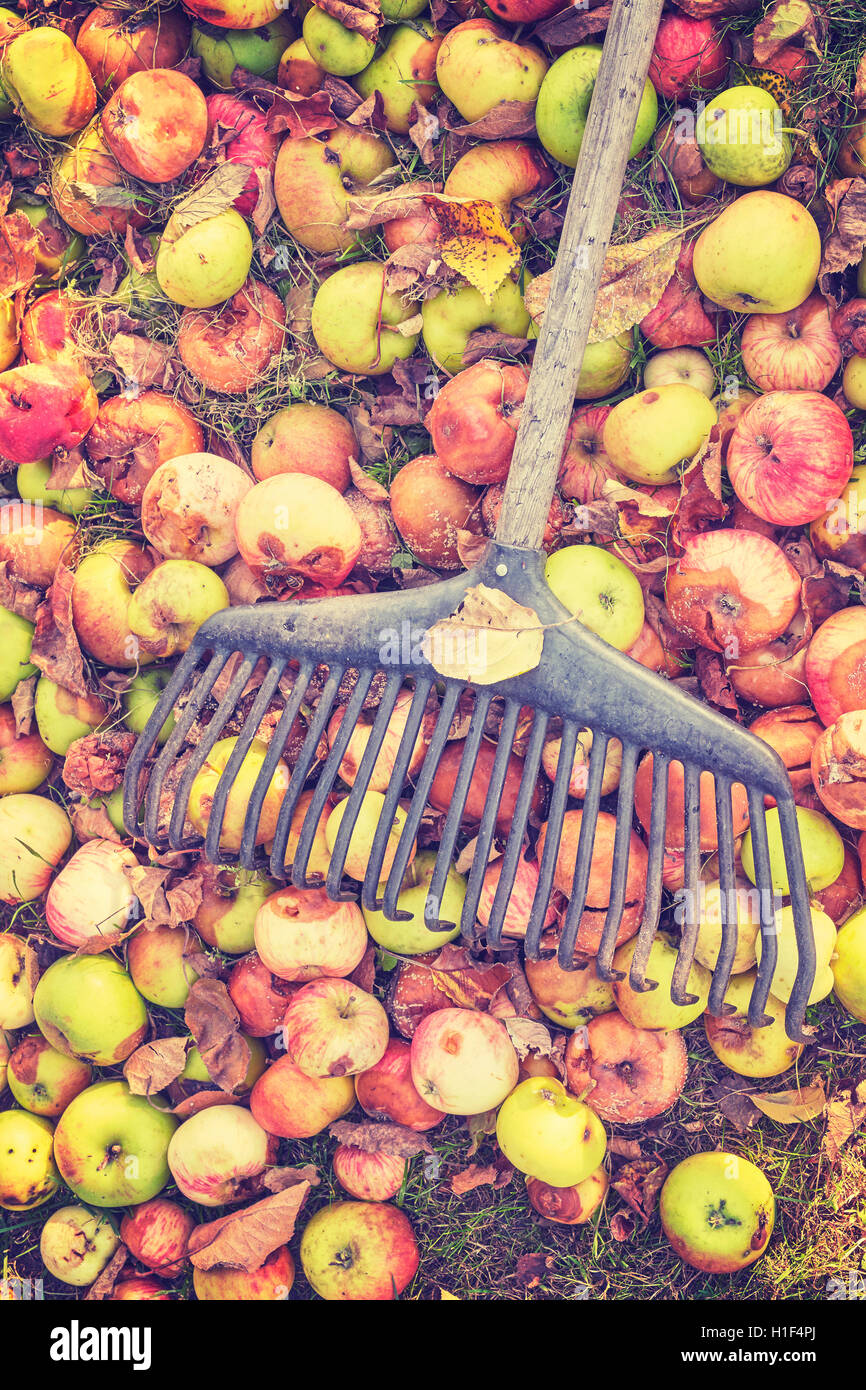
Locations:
694;189;822;314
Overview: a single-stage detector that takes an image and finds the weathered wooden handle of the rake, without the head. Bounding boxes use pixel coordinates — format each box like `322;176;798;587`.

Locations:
496;0;663;549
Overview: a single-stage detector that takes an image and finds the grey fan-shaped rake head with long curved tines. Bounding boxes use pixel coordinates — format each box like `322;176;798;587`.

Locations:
124;541;815;1041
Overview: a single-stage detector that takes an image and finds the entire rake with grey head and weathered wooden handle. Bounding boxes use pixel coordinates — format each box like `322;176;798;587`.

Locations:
124;0;815;1041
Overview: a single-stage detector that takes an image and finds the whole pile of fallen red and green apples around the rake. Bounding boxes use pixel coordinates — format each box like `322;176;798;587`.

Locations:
0;0;866;1300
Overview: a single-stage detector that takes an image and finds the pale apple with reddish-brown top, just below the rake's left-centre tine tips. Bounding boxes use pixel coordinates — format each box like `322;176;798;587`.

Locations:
254;884;369;981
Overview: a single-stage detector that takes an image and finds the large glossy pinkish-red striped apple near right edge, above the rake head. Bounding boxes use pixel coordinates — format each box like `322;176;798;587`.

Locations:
727;391;853;525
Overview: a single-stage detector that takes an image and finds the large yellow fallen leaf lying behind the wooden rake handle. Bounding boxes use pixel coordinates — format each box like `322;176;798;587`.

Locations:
523;228;683;343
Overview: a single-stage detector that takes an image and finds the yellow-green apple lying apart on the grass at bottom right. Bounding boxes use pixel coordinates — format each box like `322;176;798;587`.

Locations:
659;1154;776;1275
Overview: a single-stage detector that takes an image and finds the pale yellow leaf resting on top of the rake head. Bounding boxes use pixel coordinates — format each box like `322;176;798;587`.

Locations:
423;584;544;685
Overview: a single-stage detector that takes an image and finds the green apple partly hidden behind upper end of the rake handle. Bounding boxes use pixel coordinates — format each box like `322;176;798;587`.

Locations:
535;43;659;168
